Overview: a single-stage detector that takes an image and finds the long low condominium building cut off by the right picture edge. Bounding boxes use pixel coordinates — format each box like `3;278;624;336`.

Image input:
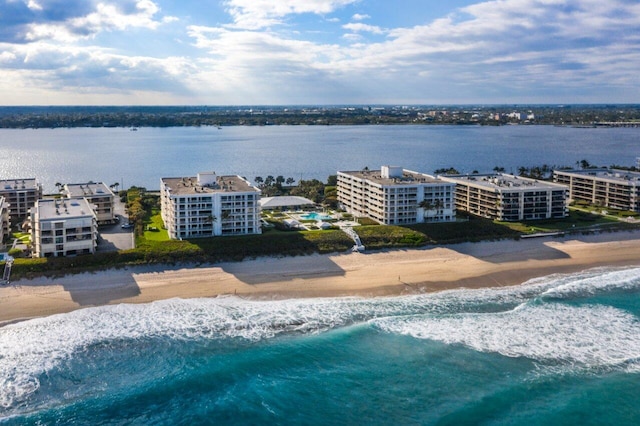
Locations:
553;169;640;212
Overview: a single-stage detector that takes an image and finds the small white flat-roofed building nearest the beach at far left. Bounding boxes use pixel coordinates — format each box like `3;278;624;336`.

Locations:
30;198;98;257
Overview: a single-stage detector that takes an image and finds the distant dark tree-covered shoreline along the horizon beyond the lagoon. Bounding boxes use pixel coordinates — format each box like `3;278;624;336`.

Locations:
0;104;640;129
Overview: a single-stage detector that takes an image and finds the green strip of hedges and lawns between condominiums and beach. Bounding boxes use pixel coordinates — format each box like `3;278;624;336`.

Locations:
5;189;639;279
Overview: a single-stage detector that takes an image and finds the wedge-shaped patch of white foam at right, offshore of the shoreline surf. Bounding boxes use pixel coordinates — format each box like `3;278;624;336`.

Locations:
372;304;640;367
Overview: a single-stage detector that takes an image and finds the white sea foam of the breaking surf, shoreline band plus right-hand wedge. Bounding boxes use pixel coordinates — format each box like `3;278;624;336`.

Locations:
0;268;640;412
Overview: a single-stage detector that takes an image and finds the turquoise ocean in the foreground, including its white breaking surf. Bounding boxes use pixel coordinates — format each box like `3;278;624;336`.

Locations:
0;267;640;425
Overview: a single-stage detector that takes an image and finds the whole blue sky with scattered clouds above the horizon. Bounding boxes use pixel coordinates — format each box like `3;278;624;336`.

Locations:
0;0;640;105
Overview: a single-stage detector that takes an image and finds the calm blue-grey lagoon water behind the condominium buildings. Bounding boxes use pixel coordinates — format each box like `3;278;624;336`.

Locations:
0;126;640;192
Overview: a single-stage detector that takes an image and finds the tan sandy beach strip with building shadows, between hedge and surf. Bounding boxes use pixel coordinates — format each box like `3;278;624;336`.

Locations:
0;231;640;325
